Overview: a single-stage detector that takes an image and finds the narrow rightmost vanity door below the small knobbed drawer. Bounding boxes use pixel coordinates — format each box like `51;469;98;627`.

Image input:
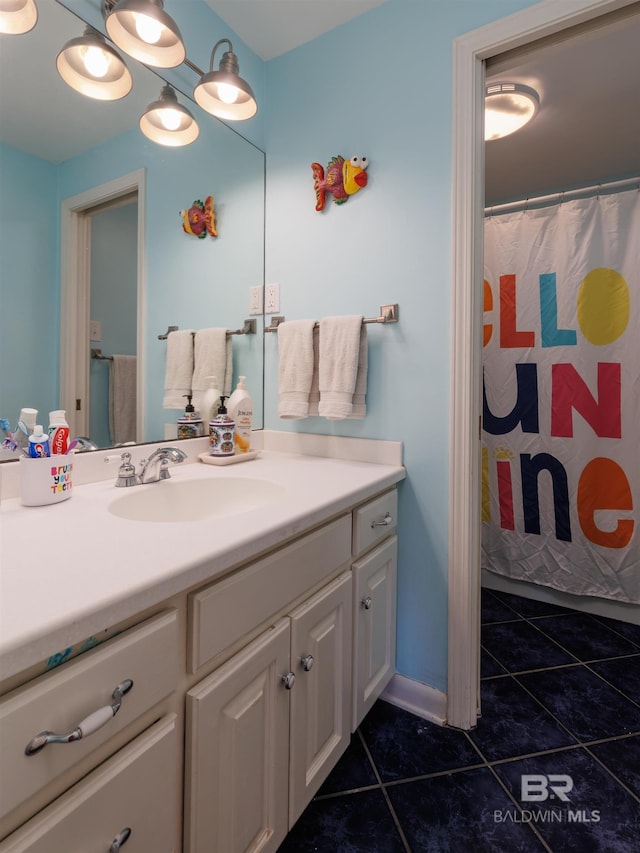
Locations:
352;536;398;731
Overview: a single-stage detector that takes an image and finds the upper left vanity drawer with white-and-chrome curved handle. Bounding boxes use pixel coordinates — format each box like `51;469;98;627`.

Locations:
0;610;178;816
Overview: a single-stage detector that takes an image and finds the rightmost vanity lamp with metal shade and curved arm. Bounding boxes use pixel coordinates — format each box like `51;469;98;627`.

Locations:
193;39;258;121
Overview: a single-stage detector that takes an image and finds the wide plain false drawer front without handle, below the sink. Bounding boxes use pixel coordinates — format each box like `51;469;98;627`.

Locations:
189;516;351;673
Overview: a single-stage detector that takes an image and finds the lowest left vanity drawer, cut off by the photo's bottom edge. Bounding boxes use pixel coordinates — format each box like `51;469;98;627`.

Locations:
0;715;179;853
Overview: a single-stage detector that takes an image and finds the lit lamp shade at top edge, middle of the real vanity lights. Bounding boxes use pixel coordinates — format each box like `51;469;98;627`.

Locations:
105;0;186;68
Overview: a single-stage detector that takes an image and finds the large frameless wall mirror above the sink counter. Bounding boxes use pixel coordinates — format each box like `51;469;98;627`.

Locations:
0;0;264;458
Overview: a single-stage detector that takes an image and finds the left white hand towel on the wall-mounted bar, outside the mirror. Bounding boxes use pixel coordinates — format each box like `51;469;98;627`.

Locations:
278;320;315;419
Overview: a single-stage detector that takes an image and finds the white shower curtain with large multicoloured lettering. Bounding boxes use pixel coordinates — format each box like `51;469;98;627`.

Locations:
482;188;640;603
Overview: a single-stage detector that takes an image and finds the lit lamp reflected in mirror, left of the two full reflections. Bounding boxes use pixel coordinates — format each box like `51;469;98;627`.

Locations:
56;27;133;101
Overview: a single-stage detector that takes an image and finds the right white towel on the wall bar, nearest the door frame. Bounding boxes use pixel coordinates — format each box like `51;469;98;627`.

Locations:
318;314;367;420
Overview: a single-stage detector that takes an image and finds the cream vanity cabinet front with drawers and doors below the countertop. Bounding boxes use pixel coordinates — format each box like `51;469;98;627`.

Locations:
0;488;397;853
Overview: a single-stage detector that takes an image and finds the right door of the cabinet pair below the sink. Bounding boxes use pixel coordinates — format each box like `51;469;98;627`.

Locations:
289;572;352;828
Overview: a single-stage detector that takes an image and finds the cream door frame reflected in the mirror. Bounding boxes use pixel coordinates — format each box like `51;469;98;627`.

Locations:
60;169;146;442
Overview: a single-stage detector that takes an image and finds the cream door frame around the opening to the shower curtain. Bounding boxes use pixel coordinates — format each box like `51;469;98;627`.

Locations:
447;0;635;729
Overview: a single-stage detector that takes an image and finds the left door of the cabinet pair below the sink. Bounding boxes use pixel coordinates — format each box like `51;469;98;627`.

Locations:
185;619;290;853
